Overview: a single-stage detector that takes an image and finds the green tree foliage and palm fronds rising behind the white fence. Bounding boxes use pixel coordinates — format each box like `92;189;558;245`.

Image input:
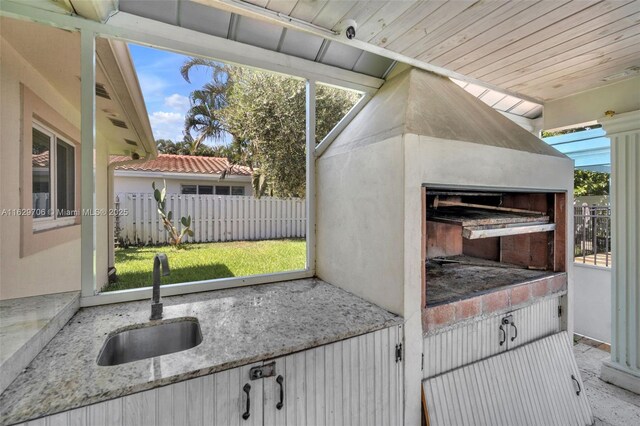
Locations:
182;58;358;197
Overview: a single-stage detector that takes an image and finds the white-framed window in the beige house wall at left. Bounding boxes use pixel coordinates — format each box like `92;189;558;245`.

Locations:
31;124;76;230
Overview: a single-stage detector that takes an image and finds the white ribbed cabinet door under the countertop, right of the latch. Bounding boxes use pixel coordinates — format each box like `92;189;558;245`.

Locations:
264;327;403;426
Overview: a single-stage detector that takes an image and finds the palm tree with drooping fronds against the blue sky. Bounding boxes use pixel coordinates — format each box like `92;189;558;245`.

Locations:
180;58;230;154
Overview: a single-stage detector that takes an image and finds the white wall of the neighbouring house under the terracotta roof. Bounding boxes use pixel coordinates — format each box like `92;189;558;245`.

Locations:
113;175;253;195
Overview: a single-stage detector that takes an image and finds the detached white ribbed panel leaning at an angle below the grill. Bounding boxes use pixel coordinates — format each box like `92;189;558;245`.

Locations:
423;331;593;426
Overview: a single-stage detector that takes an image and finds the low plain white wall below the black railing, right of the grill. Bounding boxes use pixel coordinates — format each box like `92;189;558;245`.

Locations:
573;263;611;343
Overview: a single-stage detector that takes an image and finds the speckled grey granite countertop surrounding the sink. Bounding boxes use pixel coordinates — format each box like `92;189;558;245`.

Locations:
0;279;402;425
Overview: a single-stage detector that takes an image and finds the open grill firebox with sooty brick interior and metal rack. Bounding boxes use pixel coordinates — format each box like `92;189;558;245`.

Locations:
423;187;566;308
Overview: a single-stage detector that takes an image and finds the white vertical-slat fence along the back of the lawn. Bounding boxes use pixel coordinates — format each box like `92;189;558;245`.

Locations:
115;193;307;245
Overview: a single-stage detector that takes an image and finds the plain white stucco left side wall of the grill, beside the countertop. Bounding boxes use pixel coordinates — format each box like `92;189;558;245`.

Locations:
316;136;404;315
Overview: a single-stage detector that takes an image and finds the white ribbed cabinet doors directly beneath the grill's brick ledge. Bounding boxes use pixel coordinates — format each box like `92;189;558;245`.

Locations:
422;297;561;379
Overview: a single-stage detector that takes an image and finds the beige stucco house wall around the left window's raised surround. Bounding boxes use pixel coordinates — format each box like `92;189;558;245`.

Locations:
0;39;80;299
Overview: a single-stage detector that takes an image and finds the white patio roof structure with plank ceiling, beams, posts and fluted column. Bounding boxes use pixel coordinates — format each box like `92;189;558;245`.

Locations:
1;0;640;424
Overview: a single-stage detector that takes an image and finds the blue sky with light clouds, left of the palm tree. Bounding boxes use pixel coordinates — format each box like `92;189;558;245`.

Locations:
129;44;211;142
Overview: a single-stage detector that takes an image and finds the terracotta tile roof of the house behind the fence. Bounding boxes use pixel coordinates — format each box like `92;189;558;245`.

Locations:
110;154;251;176
